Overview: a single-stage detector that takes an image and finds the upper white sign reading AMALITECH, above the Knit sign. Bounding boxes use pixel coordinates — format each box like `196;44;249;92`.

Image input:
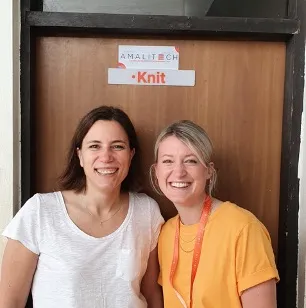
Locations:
118;45;179;70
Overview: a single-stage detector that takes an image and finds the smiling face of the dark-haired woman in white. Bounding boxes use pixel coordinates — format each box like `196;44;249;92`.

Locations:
78;120;134;191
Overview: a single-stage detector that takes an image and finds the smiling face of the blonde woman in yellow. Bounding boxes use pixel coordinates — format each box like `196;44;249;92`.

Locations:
155;136;211;206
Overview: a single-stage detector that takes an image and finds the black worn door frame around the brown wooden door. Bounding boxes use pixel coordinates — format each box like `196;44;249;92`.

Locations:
20;0;306;308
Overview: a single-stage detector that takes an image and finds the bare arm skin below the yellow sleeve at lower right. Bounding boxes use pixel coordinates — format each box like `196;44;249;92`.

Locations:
241;279;276;308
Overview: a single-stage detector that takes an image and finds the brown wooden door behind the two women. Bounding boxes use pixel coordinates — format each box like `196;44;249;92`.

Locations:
34;37;285;253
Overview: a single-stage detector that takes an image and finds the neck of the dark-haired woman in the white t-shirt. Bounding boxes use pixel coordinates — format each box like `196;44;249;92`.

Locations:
84;187;121;216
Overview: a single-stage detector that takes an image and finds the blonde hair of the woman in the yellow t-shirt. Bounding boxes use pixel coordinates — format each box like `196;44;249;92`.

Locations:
150;120;217;196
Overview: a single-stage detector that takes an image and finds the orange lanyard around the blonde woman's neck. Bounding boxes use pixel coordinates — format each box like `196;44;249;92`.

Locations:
170;196;212;308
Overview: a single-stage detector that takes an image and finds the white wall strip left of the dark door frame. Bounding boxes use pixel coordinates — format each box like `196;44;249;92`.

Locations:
0;0;20;257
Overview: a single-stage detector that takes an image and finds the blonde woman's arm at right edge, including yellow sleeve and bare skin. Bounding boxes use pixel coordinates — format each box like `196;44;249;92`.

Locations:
236;220;279;308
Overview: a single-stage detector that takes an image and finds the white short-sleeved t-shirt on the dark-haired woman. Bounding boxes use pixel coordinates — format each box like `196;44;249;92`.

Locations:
3;192;164;308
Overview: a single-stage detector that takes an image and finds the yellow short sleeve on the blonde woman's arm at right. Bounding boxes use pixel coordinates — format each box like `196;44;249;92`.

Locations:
236;221;279;296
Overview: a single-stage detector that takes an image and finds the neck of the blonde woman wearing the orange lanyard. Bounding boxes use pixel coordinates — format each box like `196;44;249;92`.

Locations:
175;195;206;225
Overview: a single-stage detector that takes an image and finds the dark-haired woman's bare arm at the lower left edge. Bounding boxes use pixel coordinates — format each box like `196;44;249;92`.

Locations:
0;239;38;308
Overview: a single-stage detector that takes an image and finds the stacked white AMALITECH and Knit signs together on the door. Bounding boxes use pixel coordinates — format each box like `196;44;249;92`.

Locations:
108;45;195;87
